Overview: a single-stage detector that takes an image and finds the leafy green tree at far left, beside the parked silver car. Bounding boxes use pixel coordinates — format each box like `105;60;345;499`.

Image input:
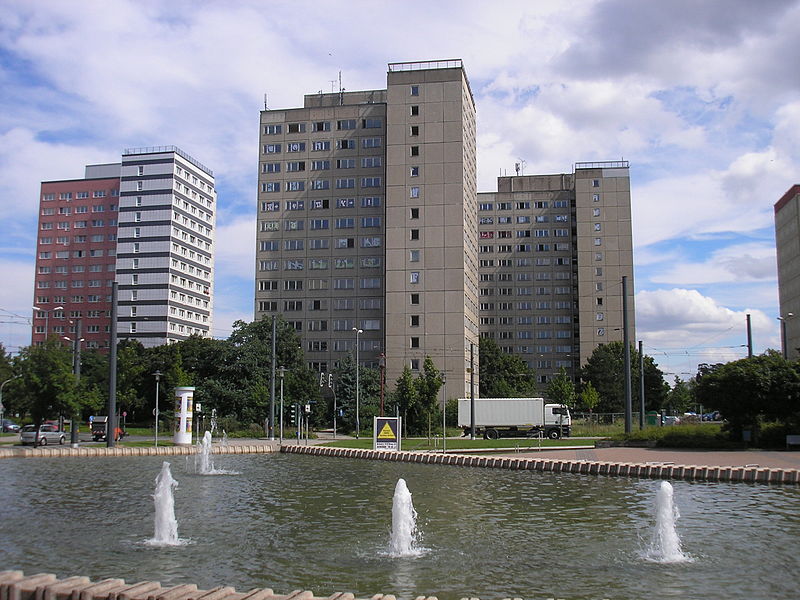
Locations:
12;337;80;446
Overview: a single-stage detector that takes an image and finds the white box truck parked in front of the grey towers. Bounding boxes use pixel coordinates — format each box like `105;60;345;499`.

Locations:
458;398;572;440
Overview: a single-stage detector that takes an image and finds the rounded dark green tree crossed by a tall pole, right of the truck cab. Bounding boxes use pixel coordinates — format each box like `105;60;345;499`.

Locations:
581;342;669;412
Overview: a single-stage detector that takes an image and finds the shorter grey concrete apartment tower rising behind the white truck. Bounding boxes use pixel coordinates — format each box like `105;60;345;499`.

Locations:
478;161;636;387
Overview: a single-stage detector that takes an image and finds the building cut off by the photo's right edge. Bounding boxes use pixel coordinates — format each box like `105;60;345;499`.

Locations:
775;184;800;360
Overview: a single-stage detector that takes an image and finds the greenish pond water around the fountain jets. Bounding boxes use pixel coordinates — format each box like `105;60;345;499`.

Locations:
0;454;800;600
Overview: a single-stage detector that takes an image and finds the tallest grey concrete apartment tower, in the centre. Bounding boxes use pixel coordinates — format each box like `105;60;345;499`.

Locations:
255;60;478;395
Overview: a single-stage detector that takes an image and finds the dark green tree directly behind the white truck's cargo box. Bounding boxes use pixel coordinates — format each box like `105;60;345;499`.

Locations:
478;338;537;398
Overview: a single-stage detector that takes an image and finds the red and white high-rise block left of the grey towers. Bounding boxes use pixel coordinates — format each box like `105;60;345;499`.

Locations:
32;146;216;348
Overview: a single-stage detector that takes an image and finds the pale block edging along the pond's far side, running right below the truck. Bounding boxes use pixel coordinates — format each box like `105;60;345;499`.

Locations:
281;446;800;484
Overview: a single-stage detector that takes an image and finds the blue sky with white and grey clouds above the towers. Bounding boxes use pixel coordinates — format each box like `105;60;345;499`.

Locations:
0;0;800;381
